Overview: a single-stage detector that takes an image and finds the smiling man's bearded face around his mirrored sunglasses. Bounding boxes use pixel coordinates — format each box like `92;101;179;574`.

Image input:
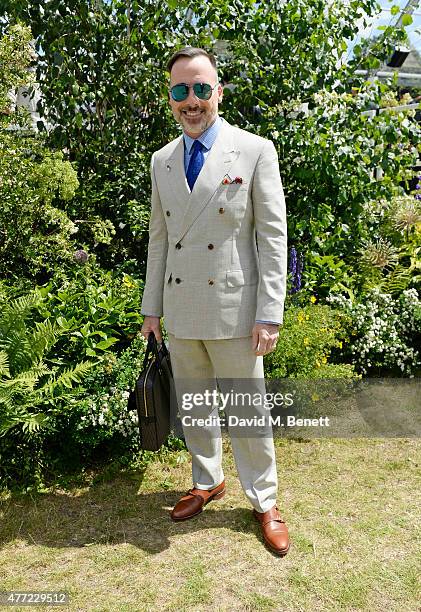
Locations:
169;55;222;138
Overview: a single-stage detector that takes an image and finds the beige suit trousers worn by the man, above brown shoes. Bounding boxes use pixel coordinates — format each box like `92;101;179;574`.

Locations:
168;333;278;512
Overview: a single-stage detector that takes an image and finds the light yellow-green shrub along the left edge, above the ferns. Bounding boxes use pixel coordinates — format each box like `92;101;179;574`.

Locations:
0;24;79;281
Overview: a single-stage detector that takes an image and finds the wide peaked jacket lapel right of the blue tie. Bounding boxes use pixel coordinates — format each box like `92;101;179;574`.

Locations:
177;121;240;242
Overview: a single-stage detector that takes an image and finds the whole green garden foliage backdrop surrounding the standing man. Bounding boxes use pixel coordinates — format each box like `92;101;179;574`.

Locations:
0;0;421;487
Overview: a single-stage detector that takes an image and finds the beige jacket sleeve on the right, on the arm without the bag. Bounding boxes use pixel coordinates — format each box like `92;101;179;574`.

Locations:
252;140;287;323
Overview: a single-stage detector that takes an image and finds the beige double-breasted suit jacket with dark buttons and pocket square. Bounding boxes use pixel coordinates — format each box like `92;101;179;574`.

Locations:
141;121;287;340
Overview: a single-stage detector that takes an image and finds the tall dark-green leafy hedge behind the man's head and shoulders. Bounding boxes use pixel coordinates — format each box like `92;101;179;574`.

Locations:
2;0;419;275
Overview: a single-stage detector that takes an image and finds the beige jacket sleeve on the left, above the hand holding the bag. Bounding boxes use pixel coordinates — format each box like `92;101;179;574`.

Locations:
141;155;168;317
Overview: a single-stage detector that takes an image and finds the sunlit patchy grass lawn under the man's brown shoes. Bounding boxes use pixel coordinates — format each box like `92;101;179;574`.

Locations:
0;439;421;612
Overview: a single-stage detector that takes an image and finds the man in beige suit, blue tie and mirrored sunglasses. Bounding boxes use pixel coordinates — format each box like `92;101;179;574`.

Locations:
141;47;289;555
